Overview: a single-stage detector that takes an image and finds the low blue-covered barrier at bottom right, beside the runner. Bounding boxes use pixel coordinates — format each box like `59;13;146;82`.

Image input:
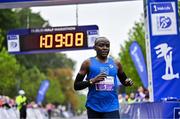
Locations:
120;101;180;119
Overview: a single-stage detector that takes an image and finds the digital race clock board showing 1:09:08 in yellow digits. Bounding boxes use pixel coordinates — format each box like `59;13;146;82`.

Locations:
7;25;99;54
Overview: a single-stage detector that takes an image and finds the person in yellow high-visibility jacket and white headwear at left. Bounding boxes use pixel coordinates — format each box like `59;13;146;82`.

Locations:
16;90;27;119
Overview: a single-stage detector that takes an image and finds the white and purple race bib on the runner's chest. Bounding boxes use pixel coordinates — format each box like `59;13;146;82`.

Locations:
95;76;114;91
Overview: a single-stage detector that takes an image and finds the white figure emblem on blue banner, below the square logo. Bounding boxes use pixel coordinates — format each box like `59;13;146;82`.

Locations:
154;43;179;80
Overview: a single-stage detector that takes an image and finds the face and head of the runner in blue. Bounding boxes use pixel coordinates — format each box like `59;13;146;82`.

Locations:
95;39;110;58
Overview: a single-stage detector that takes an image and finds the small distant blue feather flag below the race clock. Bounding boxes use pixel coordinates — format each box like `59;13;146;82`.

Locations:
36;80;50;104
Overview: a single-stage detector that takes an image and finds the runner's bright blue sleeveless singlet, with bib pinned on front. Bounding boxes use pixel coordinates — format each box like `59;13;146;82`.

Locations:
86;57;119;112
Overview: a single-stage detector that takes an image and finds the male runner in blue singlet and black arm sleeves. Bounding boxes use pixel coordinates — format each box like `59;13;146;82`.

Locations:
74;37;133;119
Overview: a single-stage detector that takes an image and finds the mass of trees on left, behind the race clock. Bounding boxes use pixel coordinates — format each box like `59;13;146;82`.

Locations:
0;8;79;109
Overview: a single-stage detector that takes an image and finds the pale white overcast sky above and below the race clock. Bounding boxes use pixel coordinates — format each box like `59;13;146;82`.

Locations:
32;0;143;75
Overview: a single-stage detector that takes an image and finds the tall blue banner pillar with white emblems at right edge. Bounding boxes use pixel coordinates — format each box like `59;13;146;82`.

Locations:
146;0;180;101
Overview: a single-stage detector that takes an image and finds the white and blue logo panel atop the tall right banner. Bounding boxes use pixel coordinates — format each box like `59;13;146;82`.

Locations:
151;2;177;35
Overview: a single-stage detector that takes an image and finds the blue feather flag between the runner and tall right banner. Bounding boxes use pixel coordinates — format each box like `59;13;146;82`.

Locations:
129;41;148;89
